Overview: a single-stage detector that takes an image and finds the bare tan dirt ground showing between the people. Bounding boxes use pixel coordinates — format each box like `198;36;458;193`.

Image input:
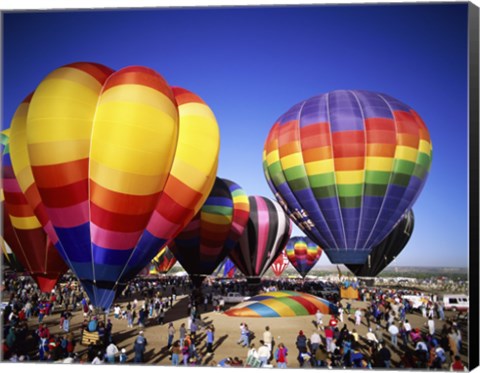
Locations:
5;284;468;368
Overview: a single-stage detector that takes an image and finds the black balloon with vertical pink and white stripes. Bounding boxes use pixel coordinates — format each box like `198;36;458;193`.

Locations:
229;196;292;278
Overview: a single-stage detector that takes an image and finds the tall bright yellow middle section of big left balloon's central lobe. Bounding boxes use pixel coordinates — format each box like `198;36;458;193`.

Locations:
90;102;178;175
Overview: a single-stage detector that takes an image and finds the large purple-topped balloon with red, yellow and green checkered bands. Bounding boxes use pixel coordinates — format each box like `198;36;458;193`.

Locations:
263;90;432;264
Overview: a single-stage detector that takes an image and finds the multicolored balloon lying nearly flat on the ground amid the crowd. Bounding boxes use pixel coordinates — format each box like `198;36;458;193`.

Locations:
225;291;337;317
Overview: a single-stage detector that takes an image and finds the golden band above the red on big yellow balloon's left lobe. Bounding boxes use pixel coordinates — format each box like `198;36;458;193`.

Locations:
28;140;90;166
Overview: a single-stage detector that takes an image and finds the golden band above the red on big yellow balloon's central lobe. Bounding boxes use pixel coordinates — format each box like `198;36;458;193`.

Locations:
90;160;168;195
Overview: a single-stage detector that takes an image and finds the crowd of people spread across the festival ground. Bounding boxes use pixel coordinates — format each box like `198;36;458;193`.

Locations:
2;270;465;370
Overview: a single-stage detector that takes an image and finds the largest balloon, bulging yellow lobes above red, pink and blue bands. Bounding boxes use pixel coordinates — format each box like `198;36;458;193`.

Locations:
12;62;219;309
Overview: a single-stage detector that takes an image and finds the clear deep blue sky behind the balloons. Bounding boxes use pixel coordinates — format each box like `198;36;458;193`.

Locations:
2;3;468;267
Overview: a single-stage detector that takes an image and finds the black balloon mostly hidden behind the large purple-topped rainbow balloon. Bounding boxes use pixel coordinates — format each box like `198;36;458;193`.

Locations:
346;210;415;277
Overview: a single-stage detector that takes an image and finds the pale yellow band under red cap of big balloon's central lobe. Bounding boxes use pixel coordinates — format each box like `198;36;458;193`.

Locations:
99;84;178;118
